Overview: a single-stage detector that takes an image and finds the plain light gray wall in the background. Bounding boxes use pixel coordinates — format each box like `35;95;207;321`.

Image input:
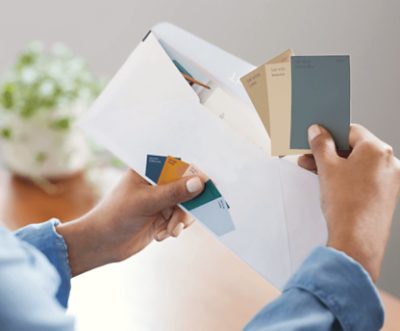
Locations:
0;0;400;296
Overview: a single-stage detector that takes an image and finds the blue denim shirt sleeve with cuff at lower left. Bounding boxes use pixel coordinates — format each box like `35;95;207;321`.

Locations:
0;220;74;331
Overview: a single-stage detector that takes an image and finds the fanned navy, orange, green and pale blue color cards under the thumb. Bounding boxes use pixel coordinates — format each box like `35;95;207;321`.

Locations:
146;155;235;236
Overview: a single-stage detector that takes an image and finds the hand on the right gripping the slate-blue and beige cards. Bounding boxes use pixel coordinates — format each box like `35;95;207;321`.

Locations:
298;124;400;281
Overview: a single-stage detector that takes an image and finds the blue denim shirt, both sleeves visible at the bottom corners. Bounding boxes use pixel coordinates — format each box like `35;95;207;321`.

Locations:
0;220;383;331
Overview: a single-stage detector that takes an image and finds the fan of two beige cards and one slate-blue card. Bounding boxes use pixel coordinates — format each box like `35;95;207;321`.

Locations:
241;49;350;156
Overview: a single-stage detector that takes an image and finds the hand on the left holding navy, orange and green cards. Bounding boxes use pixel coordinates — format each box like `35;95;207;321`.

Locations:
57;170;204;276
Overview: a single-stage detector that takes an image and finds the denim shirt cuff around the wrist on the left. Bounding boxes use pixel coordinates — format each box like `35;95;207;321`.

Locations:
15;219;71;308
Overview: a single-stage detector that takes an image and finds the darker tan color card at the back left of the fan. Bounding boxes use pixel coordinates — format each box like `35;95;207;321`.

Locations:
240;49;293;137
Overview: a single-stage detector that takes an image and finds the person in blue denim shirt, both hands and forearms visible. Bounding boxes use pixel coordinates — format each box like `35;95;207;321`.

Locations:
0;125;400;331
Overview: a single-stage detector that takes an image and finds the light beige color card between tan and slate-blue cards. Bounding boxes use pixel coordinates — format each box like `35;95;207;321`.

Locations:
265;61;310;156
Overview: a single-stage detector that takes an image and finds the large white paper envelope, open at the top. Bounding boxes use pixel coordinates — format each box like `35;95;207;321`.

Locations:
81;23;326;288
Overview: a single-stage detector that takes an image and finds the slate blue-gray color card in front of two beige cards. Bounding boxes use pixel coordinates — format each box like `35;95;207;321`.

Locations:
290;55;350;150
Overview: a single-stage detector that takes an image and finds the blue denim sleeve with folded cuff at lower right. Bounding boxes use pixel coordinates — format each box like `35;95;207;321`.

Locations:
245;247;384;331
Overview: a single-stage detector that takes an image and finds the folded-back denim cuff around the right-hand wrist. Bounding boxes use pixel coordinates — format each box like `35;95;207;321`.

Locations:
284;247;384;330
